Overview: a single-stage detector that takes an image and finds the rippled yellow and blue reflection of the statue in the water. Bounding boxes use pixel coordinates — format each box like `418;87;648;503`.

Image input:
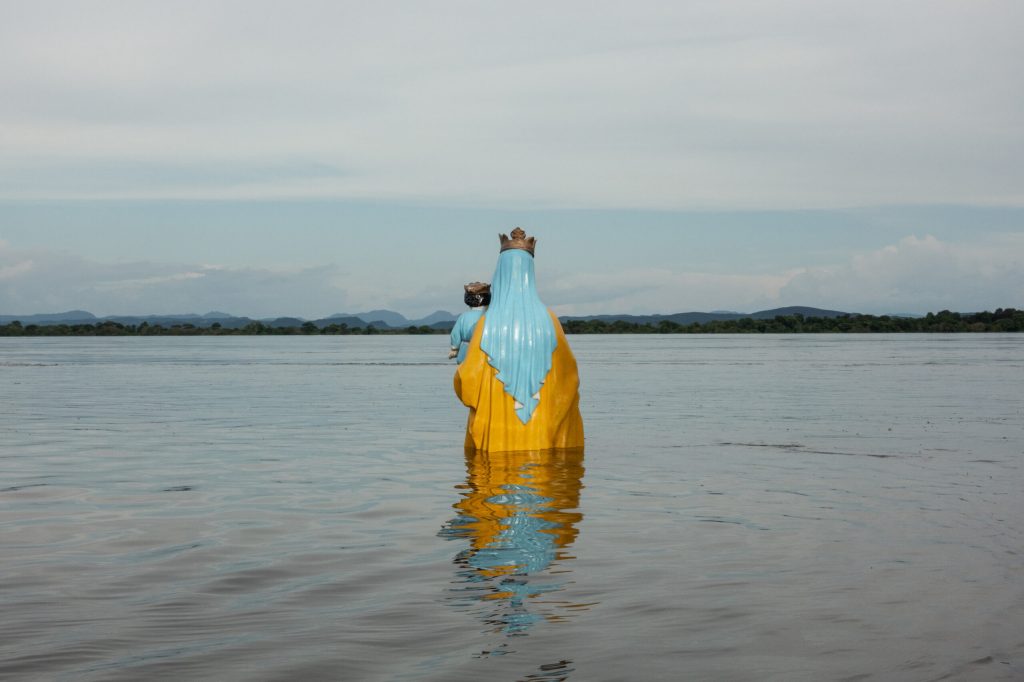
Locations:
440;447;588;636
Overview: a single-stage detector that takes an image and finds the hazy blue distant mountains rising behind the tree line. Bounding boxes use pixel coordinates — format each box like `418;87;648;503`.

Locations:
0;306;864;330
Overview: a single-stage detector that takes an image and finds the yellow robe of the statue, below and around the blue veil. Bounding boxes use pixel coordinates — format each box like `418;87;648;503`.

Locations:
455;311;583;453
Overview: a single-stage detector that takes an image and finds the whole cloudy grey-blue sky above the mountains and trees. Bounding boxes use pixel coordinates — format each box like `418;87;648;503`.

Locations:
0;0;1024;317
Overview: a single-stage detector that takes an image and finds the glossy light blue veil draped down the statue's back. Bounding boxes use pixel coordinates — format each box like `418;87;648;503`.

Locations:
480;249;558;424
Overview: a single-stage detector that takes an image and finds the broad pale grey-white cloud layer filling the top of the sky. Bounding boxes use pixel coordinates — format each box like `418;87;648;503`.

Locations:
0;0;1024;208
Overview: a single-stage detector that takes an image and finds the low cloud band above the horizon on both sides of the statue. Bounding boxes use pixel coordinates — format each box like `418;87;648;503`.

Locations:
0;232;1024;317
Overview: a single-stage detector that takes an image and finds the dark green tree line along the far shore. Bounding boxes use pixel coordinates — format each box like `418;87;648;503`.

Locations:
0;308;1024;336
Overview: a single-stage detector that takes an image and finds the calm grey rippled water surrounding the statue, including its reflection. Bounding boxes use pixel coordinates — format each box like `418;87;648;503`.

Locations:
0;335;1024;682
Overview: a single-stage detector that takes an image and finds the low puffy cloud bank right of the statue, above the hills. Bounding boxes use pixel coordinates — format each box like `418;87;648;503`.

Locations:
539;229;1024;315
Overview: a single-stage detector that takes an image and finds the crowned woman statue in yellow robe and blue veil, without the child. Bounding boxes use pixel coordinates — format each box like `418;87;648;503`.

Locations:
455;227;583;453
